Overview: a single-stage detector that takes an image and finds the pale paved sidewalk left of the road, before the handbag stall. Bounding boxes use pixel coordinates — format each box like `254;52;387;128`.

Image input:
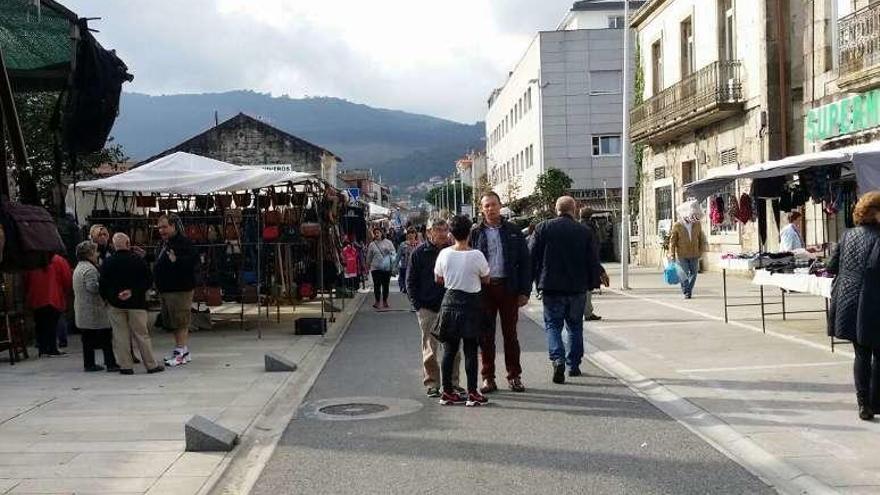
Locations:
0;296;362;495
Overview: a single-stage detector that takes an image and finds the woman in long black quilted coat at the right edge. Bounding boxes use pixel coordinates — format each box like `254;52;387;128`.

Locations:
828;191;880;421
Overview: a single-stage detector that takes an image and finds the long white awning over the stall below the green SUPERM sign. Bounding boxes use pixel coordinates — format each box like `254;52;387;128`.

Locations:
684;143;880;201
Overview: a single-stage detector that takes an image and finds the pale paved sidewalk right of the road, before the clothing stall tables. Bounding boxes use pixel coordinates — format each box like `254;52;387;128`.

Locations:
526;269;880;493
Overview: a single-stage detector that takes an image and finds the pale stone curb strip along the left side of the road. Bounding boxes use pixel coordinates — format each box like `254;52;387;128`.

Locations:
197;294;366;495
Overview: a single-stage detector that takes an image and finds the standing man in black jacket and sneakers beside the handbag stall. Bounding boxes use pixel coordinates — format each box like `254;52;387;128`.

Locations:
153;213;198;366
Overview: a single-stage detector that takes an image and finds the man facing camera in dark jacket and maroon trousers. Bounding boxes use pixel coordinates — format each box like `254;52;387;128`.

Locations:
470;191;532;394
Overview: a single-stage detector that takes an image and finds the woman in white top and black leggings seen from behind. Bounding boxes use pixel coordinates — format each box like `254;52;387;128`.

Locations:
432;216;489;406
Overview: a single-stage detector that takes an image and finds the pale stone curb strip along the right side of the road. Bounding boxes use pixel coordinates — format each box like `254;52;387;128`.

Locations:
524;302;838;494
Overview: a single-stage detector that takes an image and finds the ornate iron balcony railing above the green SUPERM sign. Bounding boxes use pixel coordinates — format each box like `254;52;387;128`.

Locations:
837;4;880;84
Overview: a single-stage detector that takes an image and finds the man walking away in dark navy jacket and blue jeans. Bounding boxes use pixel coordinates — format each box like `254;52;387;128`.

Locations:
531;196;608;383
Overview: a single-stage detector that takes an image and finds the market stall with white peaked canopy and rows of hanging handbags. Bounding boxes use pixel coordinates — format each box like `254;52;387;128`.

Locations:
68;152;358;336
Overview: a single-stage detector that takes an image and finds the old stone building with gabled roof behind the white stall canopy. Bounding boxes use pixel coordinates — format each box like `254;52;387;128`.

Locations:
144;113;342;185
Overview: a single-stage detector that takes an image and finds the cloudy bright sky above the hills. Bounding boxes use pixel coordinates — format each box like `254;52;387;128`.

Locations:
61;0;573;123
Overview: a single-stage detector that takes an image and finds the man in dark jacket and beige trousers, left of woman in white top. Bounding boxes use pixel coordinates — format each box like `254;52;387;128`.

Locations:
406;218;464;397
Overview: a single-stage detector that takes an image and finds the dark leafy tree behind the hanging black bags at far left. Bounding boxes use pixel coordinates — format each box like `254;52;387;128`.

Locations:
7;92;126;213
